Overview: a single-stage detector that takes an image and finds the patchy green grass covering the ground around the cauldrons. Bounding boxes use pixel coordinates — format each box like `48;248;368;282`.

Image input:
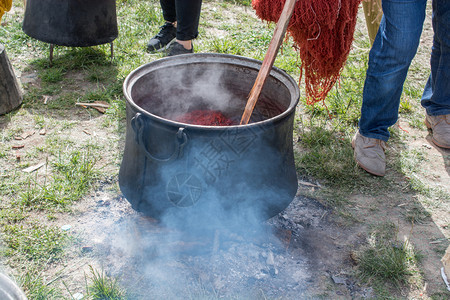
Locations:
0;0;450;299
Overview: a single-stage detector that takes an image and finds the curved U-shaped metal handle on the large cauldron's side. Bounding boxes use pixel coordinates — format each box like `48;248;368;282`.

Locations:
131;113;188;162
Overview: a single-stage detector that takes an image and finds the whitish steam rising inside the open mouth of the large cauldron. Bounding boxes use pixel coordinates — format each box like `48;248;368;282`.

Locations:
136;65;248;120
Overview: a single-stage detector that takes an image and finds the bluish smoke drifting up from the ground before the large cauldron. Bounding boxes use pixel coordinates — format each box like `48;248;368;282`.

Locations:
112;126;303;299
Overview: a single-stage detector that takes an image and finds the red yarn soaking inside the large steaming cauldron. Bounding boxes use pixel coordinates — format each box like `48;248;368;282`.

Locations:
175;110;237;126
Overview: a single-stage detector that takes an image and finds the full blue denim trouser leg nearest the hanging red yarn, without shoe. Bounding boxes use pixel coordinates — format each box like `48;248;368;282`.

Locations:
359;0;428;141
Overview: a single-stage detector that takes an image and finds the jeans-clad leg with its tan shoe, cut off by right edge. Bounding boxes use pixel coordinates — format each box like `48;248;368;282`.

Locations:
421;0;450;149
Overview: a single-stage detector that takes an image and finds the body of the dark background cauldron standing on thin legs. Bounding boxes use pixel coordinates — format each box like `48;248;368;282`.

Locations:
22;0;118;47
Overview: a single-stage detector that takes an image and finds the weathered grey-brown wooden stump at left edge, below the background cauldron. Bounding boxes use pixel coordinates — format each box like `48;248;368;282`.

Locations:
0;44;23;115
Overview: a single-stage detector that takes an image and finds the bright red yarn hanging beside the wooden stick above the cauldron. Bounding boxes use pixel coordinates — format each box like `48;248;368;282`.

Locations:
252;0;361;104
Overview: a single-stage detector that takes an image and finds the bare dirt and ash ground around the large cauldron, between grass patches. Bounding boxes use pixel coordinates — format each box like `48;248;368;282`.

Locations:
0;1;450;299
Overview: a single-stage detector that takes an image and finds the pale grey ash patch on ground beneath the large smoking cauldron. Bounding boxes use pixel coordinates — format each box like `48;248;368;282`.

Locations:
95;197;325;299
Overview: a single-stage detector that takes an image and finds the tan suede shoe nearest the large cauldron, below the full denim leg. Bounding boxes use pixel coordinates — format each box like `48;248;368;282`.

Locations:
352;131;386;176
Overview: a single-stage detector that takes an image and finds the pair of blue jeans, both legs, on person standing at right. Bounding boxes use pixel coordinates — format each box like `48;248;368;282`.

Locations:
359;0;450;141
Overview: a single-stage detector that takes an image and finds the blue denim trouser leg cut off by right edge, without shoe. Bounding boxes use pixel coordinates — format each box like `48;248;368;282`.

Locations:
421;0;450;116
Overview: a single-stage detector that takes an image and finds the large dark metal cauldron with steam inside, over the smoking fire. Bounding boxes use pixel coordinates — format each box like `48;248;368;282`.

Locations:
119;54;299;222
